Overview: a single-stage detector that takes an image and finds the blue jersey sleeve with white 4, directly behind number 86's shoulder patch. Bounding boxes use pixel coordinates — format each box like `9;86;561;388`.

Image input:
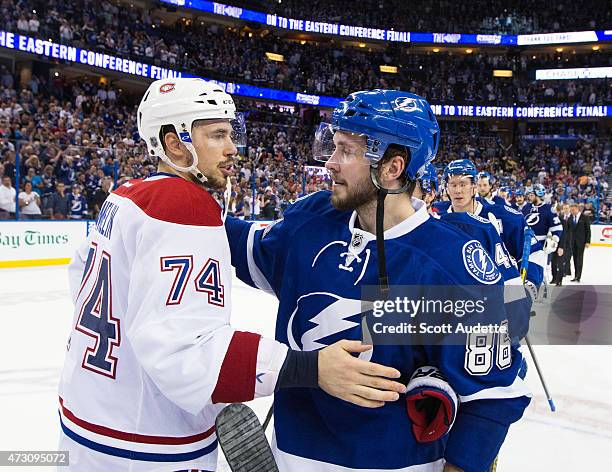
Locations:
440;212;531;339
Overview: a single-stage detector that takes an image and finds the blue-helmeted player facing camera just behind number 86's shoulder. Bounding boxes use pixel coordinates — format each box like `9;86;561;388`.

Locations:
443;159;545;300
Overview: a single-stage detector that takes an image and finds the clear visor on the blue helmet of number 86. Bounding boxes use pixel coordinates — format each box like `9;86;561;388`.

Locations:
312;123;370;165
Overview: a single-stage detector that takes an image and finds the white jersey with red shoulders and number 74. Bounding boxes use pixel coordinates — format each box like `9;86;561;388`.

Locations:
59;174;286;472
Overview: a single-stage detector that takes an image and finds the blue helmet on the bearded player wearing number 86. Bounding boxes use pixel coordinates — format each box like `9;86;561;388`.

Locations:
313;89;440;180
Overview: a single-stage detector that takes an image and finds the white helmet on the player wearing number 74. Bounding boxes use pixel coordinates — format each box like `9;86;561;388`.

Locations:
137;78;246;183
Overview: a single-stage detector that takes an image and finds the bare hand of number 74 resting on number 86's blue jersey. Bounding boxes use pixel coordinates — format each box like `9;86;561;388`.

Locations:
319;340;406;408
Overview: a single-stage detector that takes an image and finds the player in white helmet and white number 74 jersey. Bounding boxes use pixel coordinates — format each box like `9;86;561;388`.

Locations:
59;79;405;472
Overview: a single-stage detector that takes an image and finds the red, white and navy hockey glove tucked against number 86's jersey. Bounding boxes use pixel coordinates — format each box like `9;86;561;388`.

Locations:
406;366;459;443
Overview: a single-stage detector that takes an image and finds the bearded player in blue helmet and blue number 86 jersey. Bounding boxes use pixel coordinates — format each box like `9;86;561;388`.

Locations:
226;90;529;472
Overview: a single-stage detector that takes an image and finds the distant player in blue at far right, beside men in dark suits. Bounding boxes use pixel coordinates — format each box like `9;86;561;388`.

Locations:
524;184;563;280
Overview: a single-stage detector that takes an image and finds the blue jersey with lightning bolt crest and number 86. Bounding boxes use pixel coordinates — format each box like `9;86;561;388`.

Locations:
226;191;530;472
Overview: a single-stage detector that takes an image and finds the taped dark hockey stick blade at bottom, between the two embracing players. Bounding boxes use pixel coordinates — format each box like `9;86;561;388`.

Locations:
215;403;278;472
